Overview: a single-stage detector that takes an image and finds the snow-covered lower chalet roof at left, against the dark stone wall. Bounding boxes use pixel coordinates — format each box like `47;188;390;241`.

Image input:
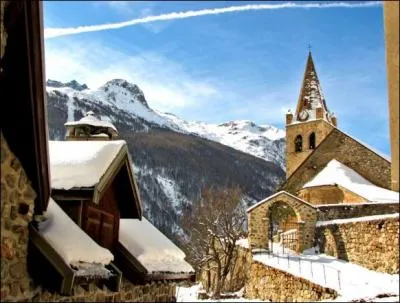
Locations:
39;198;114;265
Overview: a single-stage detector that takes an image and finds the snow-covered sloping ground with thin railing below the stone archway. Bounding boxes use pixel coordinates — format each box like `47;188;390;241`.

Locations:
253;243;399;302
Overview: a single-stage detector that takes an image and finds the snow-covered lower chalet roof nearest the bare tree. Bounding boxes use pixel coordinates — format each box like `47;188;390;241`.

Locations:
119;217;194;273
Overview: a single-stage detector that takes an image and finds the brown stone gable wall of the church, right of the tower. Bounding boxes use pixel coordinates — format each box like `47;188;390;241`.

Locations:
281;128;391;195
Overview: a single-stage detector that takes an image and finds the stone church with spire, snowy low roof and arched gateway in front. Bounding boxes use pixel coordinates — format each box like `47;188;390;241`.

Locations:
247;52;399;252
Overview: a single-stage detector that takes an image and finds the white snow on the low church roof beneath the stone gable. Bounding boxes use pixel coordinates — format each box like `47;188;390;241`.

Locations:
303;159;399;202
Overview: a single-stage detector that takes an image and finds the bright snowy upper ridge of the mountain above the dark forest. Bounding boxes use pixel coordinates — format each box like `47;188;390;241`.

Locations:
47;79;285;169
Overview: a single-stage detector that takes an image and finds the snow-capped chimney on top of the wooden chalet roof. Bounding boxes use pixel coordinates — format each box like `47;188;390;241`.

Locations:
64;111;118;141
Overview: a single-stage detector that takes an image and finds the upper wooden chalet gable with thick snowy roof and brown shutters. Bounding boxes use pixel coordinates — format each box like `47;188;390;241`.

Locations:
49;126;142;251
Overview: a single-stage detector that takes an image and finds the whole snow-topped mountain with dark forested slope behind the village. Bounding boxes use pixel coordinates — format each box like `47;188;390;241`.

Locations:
47;79;284;243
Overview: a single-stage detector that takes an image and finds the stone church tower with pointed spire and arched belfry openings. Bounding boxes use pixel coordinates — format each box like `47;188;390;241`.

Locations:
286;52;337;178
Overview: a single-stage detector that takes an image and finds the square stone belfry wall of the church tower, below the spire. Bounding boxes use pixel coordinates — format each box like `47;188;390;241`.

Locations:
286;119;333;178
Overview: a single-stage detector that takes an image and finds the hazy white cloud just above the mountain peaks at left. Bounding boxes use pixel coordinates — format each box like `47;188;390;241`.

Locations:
45;41;220;111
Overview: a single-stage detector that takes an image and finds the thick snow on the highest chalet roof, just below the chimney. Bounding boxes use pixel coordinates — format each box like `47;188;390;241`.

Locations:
49;140;126;190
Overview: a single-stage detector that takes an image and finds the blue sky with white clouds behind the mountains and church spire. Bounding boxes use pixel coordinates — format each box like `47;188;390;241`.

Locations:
44;1;390;155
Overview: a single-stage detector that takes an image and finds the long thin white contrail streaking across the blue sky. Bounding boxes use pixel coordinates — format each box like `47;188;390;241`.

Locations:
44;1;381;39
